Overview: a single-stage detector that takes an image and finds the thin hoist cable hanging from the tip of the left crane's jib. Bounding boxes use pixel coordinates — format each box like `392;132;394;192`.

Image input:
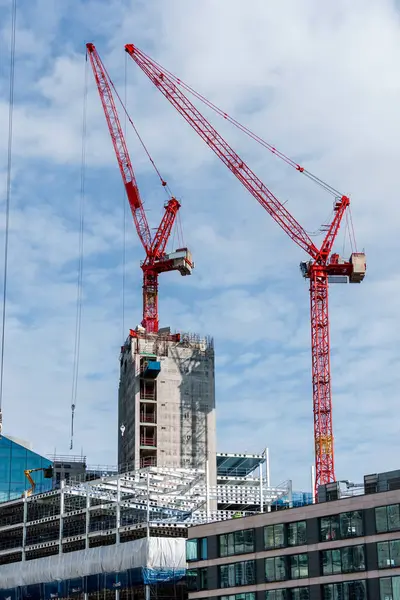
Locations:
70;51;88;450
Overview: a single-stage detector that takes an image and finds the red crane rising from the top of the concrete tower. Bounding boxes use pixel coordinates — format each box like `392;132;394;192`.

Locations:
86;43;194;333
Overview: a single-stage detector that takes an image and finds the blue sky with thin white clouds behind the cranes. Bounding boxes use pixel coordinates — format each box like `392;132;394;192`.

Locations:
0;0;400;488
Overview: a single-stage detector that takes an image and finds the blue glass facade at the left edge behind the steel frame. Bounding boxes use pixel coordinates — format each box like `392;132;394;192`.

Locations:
0;436;52;502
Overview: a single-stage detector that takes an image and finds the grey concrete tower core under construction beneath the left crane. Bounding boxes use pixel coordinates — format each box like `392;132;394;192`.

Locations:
118;327;216;485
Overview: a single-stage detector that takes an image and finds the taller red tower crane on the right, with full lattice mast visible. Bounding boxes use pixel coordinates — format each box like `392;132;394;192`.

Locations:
125;44;366;493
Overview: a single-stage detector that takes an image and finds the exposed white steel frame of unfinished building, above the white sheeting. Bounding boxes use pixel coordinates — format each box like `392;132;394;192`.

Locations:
0;467;291;575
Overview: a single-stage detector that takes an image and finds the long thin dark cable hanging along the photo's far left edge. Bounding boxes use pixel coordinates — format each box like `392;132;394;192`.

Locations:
0;0;17;436
